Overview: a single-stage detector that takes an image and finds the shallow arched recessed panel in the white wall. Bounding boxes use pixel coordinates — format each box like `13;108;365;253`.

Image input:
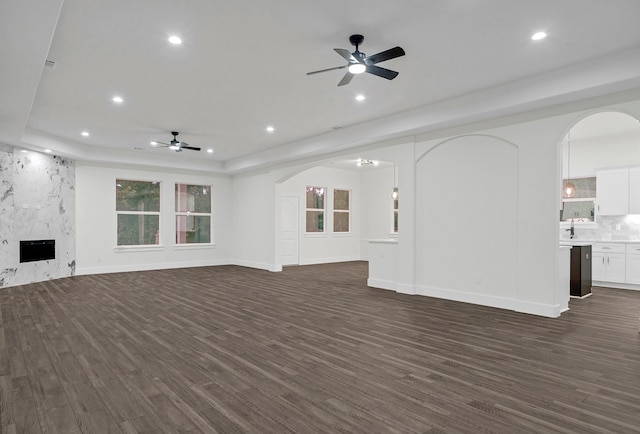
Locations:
416;135;519;309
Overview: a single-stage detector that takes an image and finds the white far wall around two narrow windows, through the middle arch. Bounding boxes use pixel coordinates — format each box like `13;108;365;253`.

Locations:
279;167;362;265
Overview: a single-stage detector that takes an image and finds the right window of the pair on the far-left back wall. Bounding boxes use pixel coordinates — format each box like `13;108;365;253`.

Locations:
176;184;211;244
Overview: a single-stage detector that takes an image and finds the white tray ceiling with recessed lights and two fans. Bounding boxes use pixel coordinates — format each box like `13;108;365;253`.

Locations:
0;0;640;173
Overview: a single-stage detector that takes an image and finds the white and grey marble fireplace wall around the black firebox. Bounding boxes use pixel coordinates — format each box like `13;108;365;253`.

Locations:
0;144;75;288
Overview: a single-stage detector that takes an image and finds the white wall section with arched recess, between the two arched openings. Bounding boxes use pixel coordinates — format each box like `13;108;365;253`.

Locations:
350;113;580;317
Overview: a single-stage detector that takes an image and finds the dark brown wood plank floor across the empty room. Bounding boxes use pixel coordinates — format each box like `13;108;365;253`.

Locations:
0;262;640;434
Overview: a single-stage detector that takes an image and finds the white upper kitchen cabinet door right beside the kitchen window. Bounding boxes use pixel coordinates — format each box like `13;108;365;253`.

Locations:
596;169;628;215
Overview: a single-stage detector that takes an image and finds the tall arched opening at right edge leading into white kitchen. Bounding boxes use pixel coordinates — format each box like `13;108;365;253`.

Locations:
560;111;640;298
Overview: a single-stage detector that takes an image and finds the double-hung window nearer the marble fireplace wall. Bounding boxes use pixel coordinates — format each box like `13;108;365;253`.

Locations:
116;179;160;246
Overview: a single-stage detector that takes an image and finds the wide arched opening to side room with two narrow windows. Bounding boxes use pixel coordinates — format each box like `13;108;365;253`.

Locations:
276;155;398;266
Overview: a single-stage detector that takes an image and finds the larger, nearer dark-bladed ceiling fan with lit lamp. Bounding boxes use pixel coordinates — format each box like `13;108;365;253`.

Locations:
307;35;405;86
